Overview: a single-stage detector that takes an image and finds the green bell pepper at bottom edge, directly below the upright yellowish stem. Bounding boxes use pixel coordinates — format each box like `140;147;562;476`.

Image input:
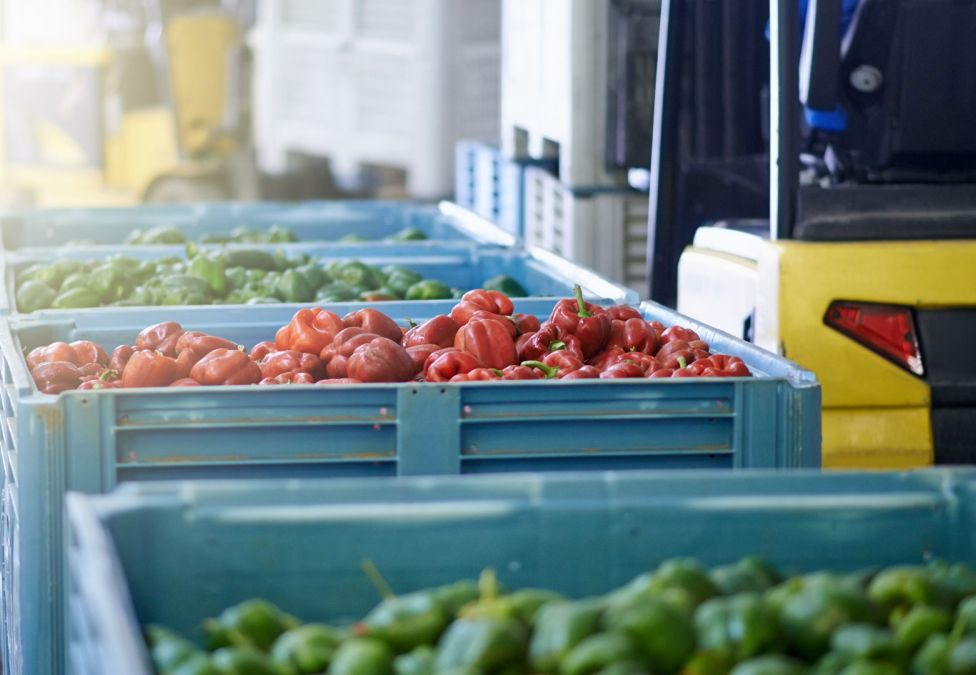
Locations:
437;618;528;673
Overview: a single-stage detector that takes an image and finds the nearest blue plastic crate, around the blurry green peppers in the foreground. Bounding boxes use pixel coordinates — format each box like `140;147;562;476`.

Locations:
68;470;976;675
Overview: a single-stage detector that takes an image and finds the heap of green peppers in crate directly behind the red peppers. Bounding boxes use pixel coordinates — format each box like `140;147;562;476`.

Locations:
16;251;527;313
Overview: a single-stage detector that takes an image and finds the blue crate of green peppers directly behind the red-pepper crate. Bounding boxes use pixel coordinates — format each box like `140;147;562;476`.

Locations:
0;243;639;317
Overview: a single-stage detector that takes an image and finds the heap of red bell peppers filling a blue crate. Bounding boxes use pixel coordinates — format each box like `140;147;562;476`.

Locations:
27;287;751;394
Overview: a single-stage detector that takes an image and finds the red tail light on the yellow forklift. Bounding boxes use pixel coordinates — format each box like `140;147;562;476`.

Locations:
824;302;925;375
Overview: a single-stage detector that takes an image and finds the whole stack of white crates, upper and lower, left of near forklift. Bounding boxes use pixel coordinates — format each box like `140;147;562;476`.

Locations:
501;0;660;294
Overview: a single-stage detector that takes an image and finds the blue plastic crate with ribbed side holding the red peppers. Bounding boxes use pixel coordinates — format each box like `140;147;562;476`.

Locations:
0;300;820;675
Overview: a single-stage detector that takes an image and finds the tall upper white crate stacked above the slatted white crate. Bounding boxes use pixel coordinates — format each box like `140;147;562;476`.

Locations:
501;0;660;188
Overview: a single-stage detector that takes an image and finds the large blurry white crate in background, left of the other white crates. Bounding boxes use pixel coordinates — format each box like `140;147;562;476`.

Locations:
253;0;501;197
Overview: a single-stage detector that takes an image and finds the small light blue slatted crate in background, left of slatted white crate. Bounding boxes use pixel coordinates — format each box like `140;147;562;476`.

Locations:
454;141;558;239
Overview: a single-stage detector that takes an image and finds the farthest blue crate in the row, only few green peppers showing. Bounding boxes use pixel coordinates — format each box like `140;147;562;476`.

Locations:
0;201;515;251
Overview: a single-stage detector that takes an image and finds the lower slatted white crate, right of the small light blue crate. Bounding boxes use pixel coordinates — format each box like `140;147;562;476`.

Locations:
523;167;648;297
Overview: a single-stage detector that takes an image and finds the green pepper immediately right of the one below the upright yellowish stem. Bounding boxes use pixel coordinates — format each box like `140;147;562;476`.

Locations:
529;600;603;673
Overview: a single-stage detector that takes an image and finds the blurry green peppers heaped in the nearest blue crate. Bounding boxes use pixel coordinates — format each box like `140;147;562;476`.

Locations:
146;557;976;675
